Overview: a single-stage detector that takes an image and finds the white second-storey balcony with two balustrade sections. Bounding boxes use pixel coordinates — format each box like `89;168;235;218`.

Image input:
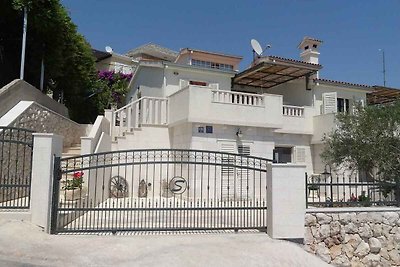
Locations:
168;85;313;134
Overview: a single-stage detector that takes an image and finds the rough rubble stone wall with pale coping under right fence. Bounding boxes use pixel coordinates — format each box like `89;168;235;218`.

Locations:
304;208;400;267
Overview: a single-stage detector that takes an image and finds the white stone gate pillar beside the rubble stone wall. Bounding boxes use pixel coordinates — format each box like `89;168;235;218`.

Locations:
267;163;306;241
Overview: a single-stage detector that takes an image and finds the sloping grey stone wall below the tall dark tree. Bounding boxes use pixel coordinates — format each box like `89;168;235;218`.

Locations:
9;103;86;147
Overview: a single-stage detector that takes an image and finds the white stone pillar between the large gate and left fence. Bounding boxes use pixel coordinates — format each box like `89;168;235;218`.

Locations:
31;133;63;232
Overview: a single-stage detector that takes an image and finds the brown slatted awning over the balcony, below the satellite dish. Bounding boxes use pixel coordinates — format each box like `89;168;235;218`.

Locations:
233;56;322;88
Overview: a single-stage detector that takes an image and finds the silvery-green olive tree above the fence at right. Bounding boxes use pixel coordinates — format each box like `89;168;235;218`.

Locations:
321;101;400;185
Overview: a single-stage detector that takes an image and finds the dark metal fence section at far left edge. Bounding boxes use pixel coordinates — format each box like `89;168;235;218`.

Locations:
0;127;33;210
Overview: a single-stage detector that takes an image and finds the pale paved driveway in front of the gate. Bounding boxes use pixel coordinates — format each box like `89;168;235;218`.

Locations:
0;220;328;267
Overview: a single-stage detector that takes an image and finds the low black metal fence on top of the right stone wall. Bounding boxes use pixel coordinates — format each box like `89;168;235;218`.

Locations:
305;166;400;207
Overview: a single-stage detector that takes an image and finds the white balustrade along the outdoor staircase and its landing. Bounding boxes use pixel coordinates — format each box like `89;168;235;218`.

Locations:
111;97;168;137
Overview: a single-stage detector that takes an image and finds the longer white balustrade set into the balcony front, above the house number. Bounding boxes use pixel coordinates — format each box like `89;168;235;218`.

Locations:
212;90;264;107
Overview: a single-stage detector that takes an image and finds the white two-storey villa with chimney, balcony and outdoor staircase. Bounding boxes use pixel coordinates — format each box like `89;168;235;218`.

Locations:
100;37;373;174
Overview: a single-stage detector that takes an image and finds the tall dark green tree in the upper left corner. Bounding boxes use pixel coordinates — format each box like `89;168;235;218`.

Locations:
0;0;99;122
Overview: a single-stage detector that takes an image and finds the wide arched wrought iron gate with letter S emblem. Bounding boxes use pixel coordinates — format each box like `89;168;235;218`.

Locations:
51;149;268;233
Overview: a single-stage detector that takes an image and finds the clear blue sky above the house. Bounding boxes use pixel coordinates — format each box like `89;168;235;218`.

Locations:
62;0;400;88
